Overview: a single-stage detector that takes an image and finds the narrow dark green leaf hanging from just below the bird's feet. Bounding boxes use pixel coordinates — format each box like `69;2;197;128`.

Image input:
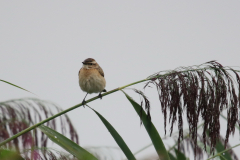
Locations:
88;106;136;160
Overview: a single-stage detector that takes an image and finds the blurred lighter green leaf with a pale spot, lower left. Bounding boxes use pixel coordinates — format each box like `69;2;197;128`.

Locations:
38;125;97;160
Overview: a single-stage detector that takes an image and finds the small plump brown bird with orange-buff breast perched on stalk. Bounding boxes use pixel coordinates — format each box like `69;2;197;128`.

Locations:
78;58;106;105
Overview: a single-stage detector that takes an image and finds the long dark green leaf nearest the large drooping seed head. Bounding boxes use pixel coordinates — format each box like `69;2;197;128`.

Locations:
122;91;170;160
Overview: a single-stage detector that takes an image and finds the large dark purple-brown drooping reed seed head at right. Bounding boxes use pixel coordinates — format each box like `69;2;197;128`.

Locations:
144;61;240;154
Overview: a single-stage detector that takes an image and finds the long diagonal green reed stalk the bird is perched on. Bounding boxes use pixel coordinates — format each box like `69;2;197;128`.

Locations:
0;65;239;147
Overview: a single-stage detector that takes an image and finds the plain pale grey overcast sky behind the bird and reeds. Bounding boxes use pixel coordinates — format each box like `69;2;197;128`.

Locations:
0;0;240;159
